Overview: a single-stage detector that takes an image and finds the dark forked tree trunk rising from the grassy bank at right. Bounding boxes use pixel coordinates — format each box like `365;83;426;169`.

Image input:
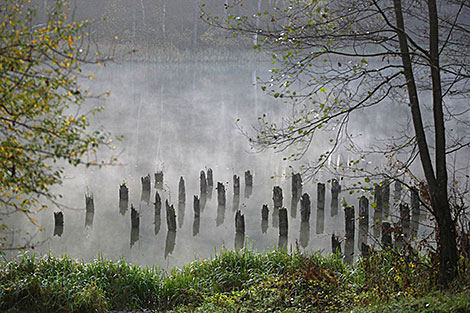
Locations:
393;0;457;288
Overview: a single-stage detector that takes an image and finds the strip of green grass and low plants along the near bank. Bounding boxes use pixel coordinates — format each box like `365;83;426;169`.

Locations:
0;249;470;312
